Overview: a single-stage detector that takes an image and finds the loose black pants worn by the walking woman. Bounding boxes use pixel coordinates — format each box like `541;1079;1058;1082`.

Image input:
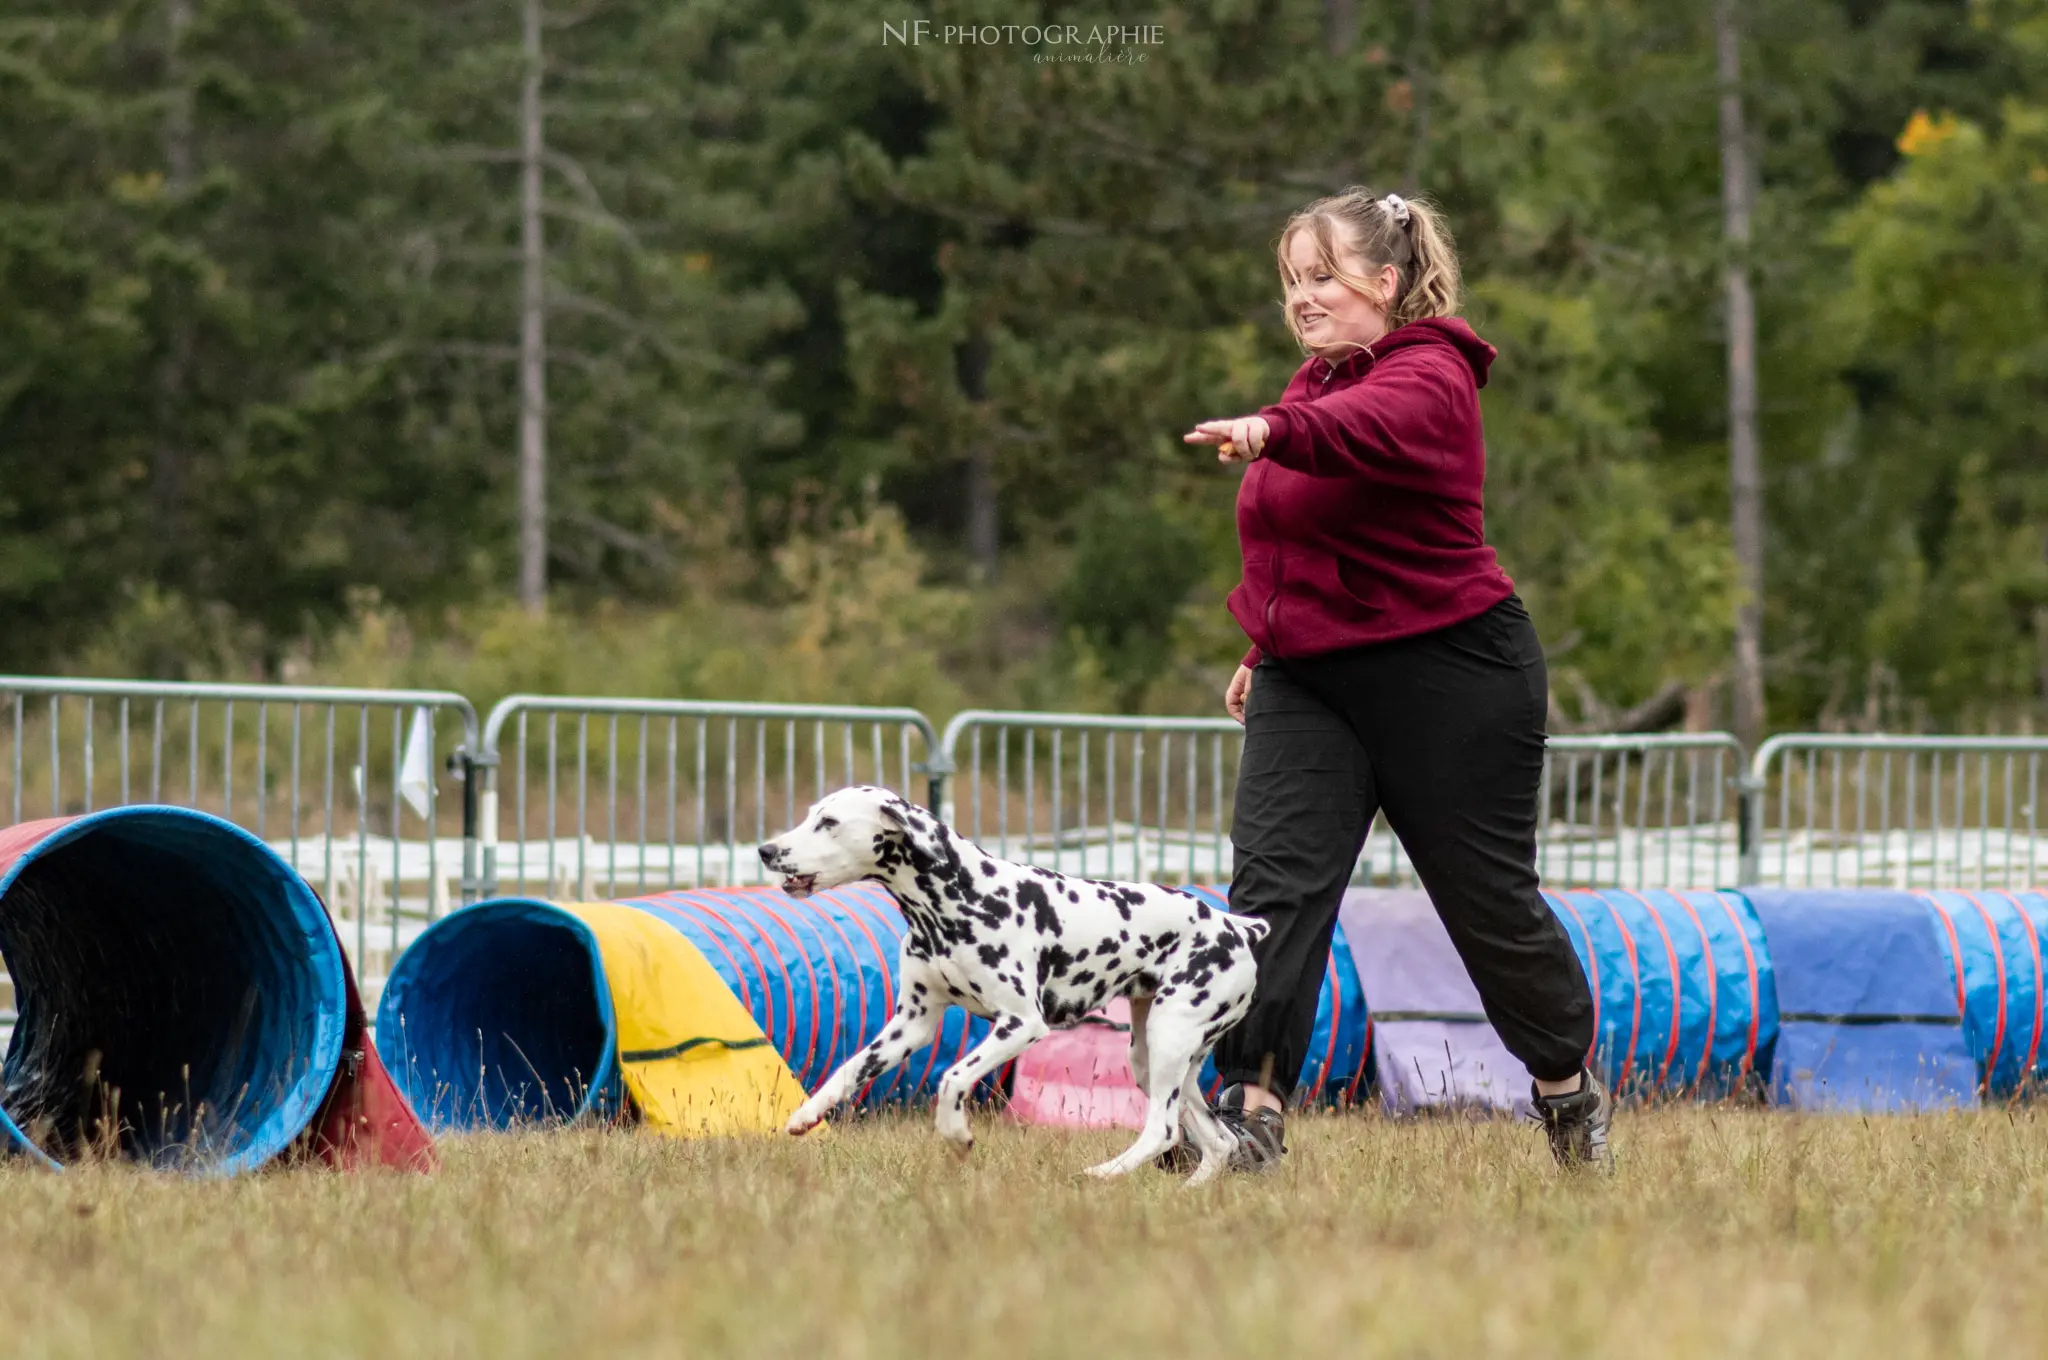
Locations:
1217;596;1593;1098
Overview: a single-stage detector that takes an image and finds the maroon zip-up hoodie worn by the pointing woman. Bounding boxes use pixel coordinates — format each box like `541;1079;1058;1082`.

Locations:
1229;317;1513;666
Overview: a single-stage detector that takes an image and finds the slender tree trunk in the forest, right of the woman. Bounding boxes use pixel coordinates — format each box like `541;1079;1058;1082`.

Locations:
1714;0;1763;750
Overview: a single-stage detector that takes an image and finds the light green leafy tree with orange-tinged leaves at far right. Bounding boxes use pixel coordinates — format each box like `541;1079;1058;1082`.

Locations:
1833;4;2048;715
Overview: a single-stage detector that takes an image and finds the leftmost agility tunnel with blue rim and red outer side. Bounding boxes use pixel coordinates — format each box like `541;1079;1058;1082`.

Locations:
0;805;432;1174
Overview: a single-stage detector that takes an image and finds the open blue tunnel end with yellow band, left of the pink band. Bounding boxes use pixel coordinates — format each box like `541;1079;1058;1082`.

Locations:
377;885;1006;1133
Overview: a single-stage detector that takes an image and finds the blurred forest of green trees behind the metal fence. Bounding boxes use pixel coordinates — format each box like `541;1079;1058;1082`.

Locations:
0;0;2048;729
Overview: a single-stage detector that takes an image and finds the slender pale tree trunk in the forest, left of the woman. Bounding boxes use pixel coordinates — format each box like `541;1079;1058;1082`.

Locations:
518;0;547;614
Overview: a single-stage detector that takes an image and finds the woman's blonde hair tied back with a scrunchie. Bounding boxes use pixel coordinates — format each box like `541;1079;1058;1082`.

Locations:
1276;184;1460;350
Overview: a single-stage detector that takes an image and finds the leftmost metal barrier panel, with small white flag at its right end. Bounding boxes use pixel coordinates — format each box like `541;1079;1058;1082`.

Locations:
0;676;477;973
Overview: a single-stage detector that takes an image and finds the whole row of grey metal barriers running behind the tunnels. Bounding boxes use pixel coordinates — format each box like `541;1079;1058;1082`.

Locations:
0;676;2048;1007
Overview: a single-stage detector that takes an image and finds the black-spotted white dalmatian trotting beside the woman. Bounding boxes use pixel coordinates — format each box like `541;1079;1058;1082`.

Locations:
760;787;1266;1184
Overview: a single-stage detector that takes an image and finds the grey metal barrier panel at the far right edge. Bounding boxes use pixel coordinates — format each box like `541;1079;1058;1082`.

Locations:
1743;733;2048;889
